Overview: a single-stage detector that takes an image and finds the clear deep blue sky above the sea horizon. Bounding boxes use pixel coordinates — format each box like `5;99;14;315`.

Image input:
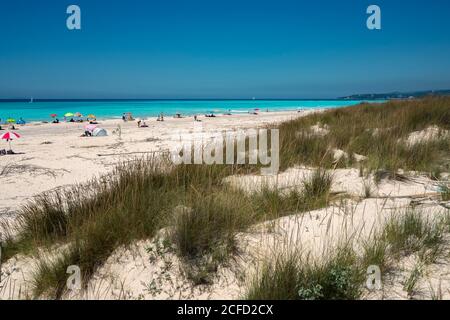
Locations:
0;0;450;98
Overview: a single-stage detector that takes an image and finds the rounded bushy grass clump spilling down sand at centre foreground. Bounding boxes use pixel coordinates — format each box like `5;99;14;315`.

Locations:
171;190;256;284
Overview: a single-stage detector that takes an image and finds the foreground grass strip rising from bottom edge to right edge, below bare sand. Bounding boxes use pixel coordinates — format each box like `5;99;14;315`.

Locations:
245;209;449;300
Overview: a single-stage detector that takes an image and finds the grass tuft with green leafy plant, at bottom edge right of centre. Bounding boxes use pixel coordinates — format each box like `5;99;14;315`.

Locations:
246;247;363;300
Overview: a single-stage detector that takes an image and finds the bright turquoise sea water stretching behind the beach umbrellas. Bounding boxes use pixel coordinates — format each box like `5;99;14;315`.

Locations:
0;100;380;122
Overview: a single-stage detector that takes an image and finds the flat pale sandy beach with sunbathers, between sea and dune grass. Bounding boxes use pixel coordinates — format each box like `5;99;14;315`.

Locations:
0;111;313;217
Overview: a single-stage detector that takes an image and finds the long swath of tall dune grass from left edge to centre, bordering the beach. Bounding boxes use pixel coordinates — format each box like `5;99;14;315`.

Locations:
0;153;328;298
